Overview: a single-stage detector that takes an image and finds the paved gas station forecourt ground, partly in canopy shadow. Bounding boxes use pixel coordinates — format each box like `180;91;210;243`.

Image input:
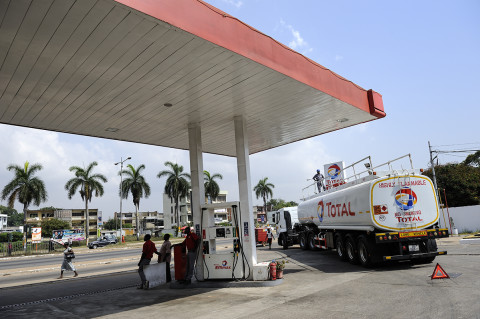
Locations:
0;241;480;319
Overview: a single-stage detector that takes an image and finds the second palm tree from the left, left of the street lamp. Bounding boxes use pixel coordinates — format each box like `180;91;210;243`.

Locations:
65;162;107;245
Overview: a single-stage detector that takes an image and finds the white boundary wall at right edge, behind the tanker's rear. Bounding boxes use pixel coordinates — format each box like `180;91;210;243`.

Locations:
440;205;480;233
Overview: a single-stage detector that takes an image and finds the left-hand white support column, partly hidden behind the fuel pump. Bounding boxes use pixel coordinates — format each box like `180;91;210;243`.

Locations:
188;123;205;281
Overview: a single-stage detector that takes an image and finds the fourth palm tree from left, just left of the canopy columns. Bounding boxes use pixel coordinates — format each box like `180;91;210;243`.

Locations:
157;162;190;236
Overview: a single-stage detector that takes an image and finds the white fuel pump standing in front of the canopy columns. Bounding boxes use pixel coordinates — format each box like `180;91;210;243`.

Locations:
201;202;245;279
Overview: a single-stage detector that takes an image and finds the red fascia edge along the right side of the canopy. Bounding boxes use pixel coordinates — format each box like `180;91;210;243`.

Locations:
115;0;385;118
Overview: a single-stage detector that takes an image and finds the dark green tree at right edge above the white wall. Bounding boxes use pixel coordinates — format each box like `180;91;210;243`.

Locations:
423;162;480;207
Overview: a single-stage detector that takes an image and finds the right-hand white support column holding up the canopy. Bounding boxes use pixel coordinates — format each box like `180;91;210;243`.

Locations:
234;116;257;280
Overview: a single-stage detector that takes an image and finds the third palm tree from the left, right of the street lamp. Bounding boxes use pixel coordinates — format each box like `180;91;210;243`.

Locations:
118;164;150;240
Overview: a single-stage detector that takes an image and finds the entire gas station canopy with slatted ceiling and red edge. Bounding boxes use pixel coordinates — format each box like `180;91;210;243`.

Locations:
0;0;385;156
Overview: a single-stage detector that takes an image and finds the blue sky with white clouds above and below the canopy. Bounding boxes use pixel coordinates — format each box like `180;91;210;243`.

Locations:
0;0;480;219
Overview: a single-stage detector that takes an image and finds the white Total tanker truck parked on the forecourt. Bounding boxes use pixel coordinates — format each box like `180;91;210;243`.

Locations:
275;154;449;267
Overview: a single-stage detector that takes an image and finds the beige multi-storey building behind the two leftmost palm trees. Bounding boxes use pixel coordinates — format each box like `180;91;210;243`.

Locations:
27;208;102;237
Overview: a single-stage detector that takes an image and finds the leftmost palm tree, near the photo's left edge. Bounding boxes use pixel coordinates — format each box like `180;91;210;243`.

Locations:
2;161;48;252
